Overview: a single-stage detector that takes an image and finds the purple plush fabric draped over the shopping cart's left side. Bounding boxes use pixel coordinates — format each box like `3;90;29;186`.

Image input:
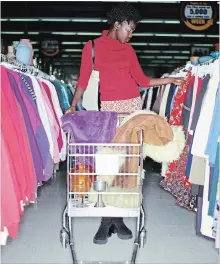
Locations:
61;111;118;166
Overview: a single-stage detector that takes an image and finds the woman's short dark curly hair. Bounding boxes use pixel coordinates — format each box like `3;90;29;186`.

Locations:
107;3;141;27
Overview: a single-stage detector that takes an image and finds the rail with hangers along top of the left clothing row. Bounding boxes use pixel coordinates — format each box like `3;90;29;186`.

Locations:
1;54;56;81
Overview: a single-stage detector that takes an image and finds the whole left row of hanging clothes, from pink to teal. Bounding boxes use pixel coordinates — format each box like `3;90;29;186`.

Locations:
0;56;72;245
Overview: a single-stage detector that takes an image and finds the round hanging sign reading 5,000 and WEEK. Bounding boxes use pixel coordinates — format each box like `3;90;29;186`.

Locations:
181;1;215;31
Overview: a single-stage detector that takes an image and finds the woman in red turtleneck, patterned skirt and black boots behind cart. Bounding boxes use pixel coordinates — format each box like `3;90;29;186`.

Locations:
66;3;182;244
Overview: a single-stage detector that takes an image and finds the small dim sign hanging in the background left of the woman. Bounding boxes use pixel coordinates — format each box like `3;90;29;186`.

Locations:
41;39;60;57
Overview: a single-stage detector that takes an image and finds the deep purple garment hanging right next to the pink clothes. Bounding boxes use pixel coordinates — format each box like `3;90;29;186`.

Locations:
7;71;44;183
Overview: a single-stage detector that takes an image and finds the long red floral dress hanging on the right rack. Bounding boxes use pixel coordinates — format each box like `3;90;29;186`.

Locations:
160;71;195;210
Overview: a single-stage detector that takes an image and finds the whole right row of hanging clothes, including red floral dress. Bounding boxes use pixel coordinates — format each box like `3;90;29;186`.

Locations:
153;59;220;252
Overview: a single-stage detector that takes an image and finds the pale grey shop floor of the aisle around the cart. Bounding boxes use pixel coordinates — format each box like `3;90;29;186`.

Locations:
1;166;219;264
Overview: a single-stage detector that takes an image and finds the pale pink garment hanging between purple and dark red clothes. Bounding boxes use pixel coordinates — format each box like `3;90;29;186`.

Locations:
38;80;60;163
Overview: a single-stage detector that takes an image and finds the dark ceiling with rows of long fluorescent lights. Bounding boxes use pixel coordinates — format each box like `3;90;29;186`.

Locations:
1;1;219;73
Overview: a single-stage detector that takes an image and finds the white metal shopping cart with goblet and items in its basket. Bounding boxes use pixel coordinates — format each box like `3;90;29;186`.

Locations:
60;114;146;264
